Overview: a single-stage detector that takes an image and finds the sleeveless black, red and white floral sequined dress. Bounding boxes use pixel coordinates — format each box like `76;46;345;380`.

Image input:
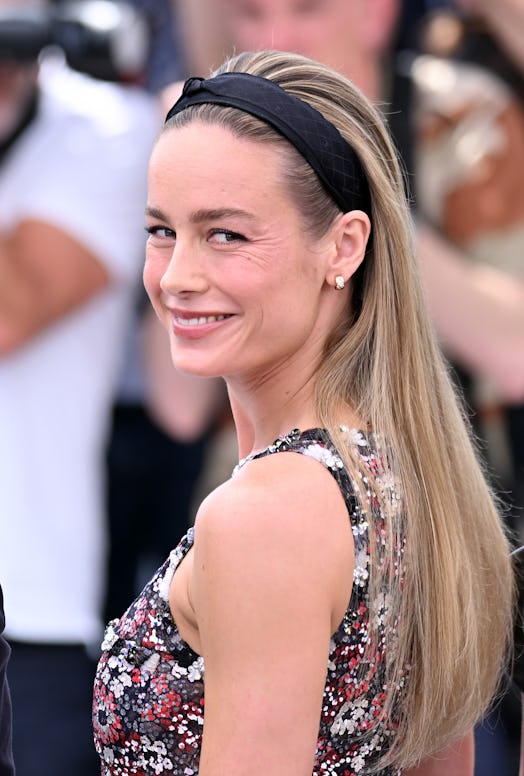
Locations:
93;427;402;776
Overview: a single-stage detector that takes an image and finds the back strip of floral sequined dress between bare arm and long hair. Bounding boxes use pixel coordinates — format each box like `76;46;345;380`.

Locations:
292;426;404;776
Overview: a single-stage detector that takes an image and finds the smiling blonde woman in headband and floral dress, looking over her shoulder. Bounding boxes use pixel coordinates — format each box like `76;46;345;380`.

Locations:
94;52;512;776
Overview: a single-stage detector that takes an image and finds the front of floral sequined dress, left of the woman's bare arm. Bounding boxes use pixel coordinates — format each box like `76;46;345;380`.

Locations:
93;529;204;776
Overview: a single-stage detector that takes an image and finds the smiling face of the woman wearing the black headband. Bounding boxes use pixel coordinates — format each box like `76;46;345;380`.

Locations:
144;122;342;382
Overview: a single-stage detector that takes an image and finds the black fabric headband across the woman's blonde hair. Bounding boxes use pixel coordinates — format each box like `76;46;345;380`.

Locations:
166;73;370;213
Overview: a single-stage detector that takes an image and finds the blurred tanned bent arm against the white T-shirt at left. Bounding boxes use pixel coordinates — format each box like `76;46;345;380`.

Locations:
0;220;109;355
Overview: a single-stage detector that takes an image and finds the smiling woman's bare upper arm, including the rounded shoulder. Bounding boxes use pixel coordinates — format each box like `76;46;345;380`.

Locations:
191;454;352;776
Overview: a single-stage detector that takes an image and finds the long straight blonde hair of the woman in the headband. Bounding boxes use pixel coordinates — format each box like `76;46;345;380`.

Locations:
169;52;513;767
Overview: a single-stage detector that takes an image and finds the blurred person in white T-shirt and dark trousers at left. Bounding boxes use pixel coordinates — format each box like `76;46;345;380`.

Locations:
0;0;159;776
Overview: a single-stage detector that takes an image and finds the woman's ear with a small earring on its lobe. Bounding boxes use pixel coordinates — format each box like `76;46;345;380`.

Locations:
326;210;371;288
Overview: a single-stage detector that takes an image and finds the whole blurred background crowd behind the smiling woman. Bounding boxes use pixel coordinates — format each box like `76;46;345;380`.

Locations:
0;0;524;776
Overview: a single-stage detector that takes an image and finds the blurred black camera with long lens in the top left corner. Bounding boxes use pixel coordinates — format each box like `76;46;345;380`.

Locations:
0;0;150;82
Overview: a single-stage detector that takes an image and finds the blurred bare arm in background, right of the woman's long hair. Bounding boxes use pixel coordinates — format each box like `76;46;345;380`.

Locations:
417;225;524;401
